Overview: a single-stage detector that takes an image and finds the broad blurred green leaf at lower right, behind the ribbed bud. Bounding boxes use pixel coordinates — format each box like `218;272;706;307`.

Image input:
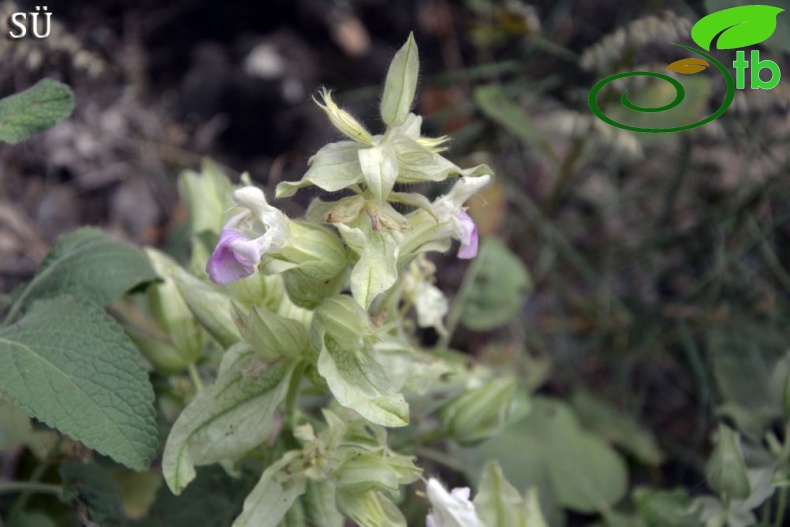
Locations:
454;397;628;512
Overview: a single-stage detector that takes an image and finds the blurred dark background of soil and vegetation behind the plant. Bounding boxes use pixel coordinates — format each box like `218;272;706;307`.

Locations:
0;0;790;526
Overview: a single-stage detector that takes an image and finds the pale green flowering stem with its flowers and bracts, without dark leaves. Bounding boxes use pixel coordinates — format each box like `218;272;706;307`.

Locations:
152;37;540;527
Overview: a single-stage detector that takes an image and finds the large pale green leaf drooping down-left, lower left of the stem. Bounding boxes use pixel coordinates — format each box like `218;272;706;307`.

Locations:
162;344;294;494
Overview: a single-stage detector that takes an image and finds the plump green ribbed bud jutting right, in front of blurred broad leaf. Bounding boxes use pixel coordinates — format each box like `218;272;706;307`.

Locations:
439;378;516;445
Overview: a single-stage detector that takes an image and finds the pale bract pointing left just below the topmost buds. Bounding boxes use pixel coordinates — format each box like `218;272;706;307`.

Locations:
276;141;362;198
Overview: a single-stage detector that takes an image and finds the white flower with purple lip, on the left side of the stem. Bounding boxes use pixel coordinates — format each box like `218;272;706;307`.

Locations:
206;187;290;284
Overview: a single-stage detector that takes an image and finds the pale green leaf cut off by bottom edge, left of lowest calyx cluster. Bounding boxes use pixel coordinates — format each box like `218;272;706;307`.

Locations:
233;452;307;527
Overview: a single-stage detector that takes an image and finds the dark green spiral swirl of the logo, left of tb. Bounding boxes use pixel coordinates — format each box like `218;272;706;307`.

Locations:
587;42;735;134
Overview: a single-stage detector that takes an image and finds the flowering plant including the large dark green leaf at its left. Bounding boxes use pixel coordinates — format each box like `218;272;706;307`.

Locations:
0;37;544;527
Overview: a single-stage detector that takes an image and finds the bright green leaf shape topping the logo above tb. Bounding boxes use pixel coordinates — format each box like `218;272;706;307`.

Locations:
691;5;784;51
